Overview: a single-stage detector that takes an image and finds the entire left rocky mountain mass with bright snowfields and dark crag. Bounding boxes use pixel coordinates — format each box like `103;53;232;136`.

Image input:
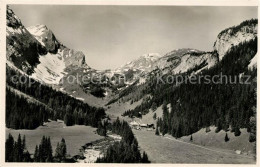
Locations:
6;7;89;84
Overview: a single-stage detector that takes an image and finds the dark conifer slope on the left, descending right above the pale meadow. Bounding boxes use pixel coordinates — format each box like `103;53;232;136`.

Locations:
6;66;105;129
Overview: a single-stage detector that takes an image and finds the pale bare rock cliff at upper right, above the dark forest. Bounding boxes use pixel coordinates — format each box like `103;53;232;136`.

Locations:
214;19;258;60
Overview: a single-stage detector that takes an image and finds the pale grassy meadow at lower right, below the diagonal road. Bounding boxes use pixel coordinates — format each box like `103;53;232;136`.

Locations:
133;130;256;164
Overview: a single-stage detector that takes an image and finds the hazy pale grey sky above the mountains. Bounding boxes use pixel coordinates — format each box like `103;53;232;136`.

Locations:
10;5;257;69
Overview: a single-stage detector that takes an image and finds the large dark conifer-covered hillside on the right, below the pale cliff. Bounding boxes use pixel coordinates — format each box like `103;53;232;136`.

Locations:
124;38;257;140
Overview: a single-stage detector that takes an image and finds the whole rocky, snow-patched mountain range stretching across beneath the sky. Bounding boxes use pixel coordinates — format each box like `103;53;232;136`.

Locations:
6;7;257;102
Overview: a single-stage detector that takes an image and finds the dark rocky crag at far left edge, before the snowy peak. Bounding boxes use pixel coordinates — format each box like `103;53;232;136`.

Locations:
6;7;47;74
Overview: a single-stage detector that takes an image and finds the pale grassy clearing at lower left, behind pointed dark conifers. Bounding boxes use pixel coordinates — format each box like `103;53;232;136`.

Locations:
6;121;104;156
